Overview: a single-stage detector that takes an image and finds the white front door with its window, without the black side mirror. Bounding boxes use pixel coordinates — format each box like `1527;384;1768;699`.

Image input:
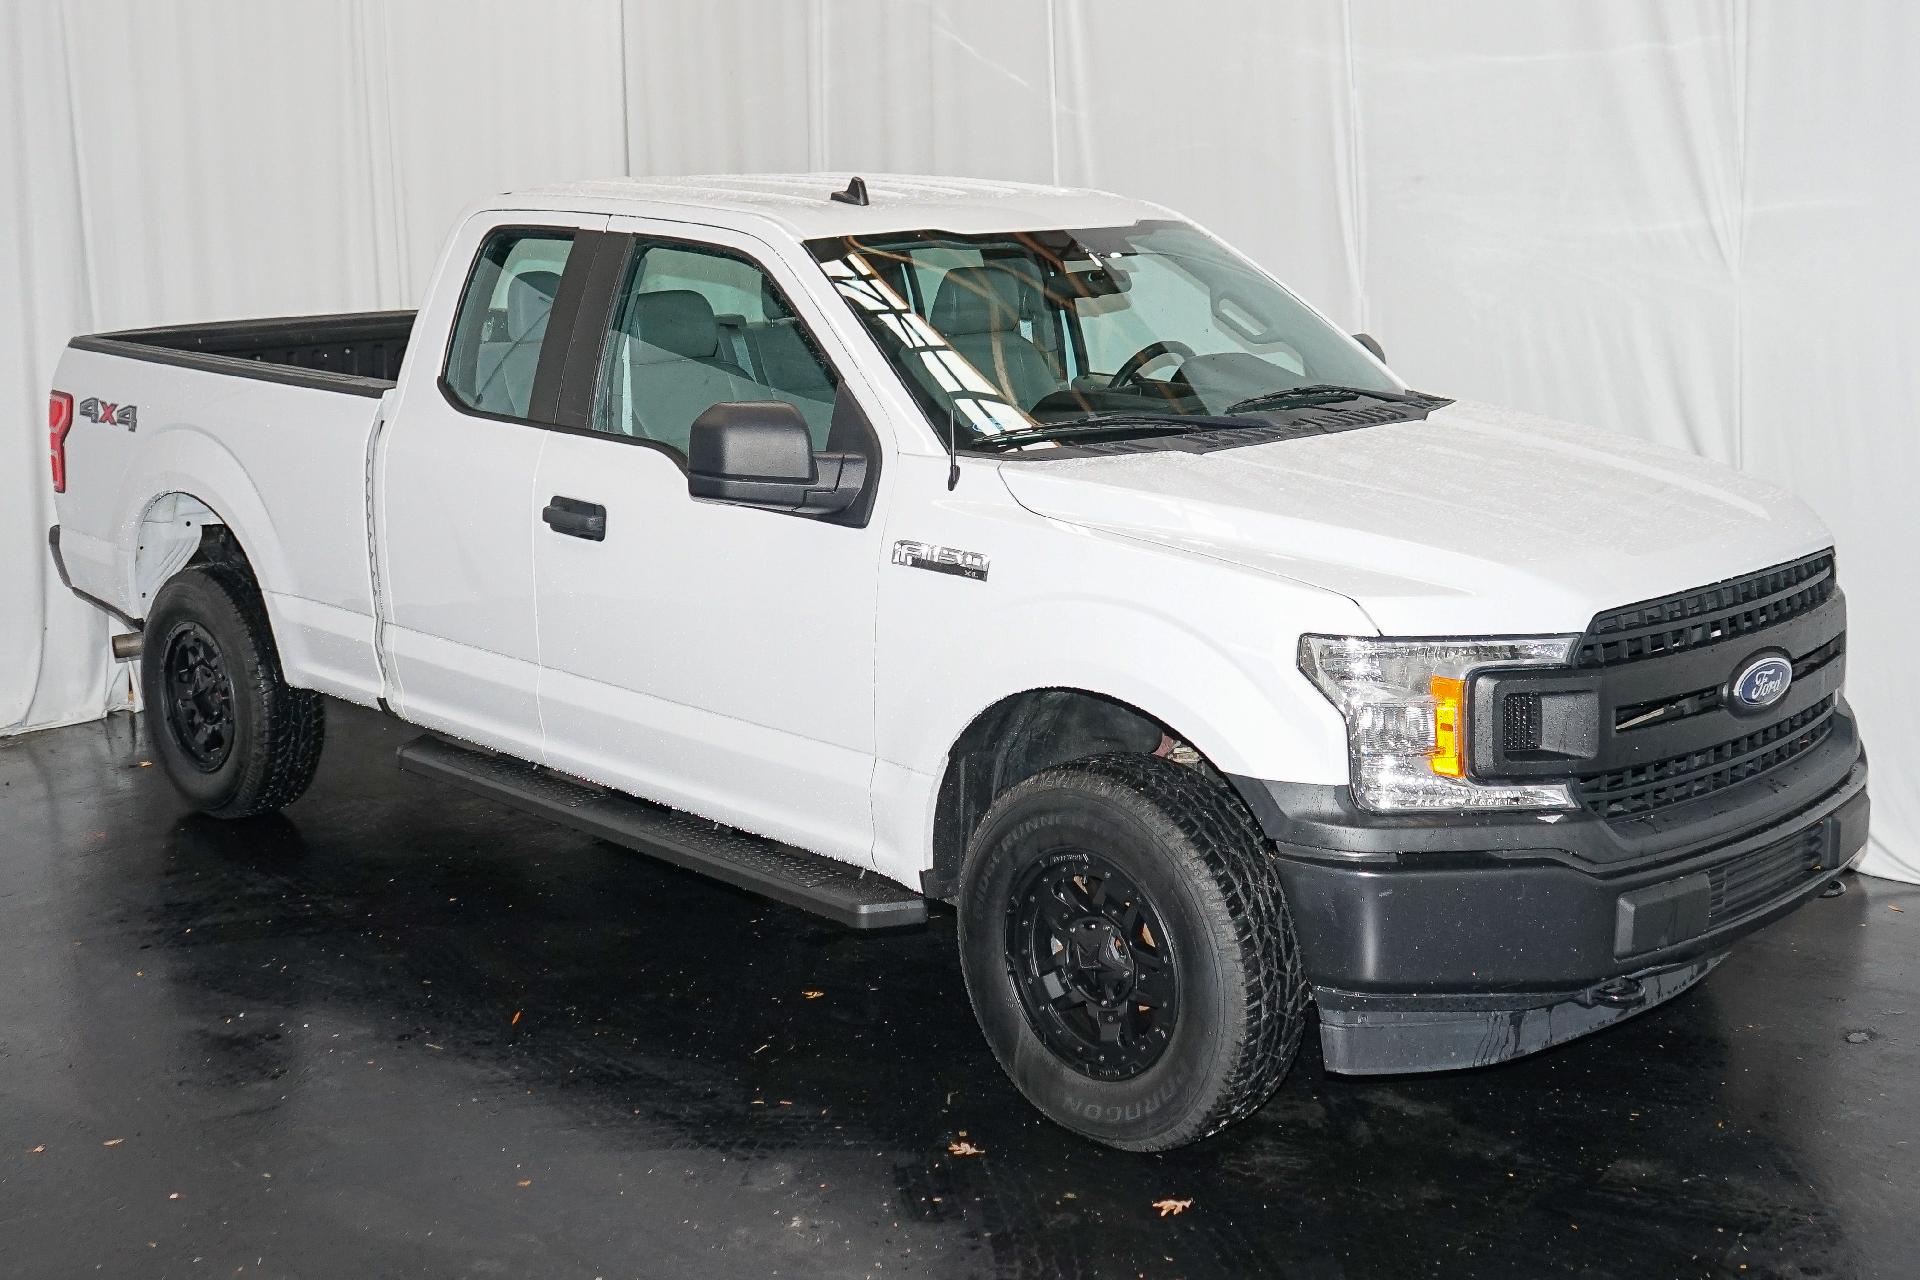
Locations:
534;219;881;864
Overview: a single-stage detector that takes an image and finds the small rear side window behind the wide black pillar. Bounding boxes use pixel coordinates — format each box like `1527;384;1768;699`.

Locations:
445;226;574;418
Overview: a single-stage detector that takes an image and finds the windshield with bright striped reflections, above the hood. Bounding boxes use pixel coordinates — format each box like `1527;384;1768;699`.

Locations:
808;223;1404;445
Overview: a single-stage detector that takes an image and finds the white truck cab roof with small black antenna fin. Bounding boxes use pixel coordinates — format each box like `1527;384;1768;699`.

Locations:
486;171;1171;240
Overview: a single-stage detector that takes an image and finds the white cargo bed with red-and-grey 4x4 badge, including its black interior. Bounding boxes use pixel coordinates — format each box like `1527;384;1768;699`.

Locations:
54;311;413;702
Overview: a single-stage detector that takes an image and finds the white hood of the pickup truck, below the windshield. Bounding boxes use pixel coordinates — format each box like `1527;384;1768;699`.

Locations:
1000;403;1832;635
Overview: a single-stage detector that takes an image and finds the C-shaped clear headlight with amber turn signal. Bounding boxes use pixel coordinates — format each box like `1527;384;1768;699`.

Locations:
1300;635;1580;812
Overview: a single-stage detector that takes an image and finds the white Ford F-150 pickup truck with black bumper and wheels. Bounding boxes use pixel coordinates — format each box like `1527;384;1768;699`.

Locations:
50;175;1868;1150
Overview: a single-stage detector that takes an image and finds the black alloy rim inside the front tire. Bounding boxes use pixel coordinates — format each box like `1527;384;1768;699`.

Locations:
1006;850;1179;1080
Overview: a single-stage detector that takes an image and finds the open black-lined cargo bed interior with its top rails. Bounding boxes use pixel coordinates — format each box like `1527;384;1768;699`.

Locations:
69;311;415;395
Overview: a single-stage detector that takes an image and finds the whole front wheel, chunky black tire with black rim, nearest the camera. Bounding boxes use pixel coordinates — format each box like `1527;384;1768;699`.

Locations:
960;756;1308;1151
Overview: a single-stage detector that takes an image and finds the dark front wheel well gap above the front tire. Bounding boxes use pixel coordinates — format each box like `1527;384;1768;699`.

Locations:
920;689;1212;898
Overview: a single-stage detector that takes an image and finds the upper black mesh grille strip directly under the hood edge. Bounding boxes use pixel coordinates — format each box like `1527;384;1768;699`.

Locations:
1576;547;1836;668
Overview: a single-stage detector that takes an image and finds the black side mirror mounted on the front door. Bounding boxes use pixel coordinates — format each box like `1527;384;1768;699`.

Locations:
687;399;866;516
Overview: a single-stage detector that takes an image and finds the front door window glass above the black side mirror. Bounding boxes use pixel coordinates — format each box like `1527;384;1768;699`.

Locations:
593;242;839;457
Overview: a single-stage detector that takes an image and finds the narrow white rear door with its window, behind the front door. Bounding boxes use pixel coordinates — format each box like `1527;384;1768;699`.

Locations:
376;211;607;760
